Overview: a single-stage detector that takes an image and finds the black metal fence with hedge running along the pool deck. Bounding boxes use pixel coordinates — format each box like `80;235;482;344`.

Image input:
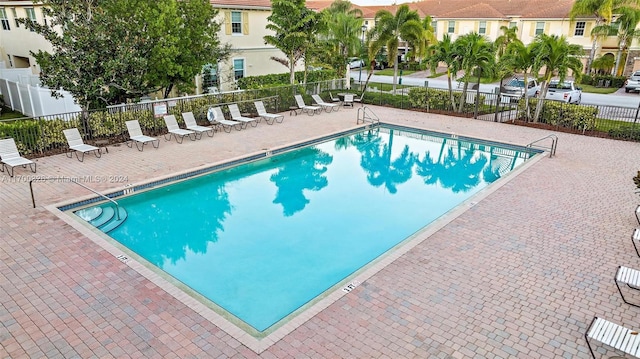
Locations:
0;79;640;157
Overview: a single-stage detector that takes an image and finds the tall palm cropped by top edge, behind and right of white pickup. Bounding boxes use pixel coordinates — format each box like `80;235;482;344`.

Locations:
569;0;638;73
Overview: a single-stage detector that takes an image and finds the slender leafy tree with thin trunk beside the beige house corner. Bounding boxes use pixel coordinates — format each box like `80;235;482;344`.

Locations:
264;0;318;85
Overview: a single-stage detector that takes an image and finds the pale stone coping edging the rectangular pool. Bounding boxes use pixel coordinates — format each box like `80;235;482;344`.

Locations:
44;123;546;354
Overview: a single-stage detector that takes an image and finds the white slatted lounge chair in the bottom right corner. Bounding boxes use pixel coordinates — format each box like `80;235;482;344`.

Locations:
584;317;640;359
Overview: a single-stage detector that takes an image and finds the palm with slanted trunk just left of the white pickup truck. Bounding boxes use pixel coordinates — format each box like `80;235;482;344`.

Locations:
530;34;582;122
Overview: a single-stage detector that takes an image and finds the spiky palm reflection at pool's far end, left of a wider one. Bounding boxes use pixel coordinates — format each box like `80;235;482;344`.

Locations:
356;130;416;193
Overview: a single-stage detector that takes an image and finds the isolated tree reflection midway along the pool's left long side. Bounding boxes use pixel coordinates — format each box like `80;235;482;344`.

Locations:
270;147;333;217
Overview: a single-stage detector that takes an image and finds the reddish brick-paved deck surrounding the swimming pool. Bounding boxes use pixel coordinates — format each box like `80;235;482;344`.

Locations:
0;106;640;358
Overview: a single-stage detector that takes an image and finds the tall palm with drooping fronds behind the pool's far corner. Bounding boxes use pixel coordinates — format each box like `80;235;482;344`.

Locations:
369;4;424;93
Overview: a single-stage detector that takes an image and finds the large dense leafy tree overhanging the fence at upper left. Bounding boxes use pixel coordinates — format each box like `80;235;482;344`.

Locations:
20;0;228;110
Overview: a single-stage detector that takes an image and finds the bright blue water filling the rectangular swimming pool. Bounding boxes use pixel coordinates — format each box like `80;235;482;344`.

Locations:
74;128;530;331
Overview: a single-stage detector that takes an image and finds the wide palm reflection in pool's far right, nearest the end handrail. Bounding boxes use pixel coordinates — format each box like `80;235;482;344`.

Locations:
416;141;488;193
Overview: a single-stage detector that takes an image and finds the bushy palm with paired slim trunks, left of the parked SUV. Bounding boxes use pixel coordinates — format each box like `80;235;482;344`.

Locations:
453;32;496;115
